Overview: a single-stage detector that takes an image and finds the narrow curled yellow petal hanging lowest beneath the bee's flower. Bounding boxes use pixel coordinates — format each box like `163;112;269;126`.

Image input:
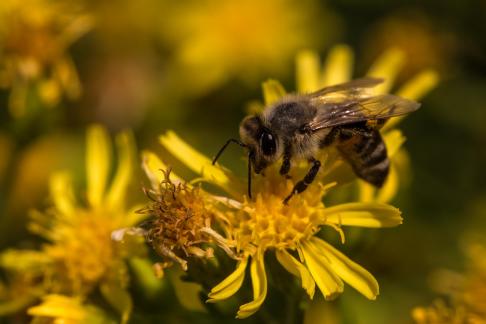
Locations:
236;253;267;319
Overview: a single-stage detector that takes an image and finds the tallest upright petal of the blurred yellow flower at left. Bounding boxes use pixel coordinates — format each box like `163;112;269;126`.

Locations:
86;125;111;206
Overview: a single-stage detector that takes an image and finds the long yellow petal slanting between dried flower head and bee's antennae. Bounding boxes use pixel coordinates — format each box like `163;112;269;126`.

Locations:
160;131;245;197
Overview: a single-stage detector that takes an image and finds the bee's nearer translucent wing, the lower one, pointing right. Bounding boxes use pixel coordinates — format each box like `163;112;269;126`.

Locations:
309;91;420;131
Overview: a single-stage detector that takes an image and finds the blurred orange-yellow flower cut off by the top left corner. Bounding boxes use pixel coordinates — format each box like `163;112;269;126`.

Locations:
0;0;93;117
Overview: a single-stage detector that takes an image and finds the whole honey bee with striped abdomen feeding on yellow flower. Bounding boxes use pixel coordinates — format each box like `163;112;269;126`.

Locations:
213;78;420;204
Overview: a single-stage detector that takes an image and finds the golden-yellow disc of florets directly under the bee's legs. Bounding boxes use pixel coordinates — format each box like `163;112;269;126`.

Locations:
232;170;324;254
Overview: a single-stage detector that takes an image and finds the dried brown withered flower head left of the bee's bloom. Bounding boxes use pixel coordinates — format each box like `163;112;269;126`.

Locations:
139;162;233;274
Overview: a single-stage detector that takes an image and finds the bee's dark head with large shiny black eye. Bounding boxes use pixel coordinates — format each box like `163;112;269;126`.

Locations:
240;116;279;174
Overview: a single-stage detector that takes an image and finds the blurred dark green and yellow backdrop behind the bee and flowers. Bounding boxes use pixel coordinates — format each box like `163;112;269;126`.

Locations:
0;0;486;323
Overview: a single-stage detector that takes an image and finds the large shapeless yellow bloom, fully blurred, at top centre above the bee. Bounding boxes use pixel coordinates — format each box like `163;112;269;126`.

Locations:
162;0;334;94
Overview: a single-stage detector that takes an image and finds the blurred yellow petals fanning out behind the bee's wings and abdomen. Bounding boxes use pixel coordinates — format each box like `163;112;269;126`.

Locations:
292;45;439;203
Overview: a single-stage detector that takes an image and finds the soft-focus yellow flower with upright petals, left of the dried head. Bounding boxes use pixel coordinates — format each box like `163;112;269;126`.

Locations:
0;126;141;321
